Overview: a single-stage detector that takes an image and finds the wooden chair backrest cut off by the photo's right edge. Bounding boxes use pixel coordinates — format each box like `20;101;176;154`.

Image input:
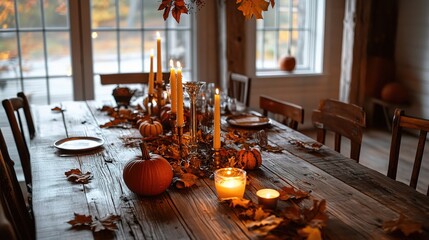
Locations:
387;109;429;196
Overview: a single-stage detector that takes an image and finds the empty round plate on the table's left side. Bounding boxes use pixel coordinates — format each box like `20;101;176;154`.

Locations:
54;137;104;151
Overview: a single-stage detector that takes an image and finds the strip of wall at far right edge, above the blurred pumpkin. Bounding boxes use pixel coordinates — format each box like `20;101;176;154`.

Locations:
395;0;429;118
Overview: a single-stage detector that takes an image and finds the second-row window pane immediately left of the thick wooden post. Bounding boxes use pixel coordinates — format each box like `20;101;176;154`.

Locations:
46;32;71;76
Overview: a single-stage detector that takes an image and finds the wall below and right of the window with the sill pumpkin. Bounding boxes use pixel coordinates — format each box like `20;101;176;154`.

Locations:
247;0;345;128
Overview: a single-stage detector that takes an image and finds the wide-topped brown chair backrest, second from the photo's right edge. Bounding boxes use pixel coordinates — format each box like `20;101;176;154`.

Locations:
312;99;366;162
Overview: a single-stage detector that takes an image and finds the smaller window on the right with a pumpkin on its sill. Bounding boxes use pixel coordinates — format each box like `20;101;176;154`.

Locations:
256;0;325;74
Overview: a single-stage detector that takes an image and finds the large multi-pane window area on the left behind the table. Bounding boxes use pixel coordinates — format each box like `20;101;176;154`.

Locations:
0;0;193;104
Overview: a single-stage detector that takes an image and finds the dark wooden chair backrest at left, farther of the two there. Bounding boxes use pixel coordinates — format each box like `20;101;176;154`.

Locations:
2;92;36;187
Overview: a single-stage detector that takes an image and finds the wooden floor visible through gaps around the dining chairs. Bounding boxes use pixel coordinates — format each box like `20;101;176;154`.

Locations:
0;107;429;194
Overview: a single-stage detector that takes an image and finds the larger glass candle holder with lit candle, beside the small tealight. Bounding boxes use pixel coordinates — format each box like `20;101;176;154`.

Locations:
214;168;246;199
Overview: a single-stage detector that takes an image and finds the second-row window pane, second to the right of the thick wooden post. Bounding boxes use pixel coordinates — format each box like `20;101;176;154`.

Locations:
120;32;142;72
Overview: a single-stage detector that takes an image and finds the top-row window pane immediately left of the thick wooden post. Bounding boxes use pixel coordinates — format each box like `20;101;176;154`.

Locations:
44;0;68;27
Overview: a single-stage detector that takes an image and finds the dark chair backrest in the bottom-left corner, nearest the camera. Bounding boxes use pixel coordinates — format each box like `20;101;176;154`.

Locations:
0;130;35;239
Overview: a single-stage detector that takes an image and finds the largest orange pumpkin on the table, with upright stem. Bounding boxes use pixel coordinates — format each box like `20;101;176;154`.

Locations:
122;143;173;196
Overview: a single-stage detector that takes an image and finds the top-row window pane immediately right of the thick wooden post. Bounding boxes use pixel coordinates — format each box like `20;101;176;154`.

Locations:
91;0;117;29
